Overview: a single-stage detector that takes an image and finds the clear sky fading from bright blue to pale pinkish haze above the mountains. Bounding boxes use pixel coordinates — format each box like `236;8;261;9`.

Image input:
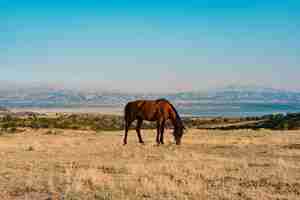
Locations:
0;0;300;91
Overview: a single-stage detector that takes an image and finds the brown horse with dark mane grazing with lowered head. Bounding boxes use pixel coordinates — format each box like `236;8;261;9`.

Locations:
123;99;185;145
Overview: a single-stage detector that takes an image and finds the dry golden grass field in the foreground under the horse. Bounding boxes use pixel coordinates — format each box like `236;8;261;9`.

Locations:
0;129;300;200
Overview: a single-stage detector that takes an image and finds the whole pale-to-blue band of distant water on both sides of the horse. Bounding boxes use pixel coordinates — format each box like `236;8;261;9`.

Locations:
11;103;300;117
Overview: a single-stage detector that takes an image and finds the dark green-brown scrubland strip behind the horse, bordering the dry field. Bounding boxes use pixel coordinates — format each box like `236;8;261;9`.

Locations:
0;112;300;132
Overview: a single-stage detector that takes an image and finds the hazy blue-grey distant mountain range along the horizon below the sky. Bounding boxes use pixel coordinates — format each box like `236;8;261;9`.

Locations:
0;85;300;107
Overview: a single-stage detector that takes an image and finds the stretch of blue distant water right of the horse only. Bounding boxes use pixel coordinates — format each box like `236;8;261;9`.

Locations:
177;103;300;117
